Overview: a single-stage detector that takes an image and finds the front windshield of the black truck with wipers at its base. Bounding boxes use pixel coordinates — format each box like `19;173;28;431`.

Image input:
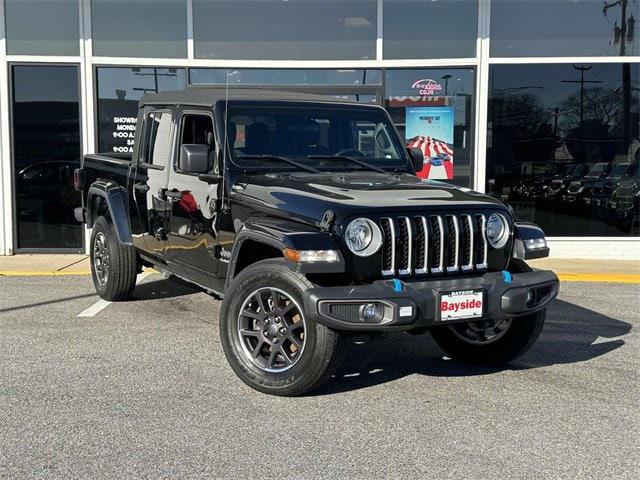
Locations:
227;106;408;170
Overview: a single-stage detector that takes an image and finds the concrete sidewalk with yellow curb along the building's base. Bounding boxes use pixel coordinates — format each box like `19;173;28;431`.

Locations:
0;254;640;285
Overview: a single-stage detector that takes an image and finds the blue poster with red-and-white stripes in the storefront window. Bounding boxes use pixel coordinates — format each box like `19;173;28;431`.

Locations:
405;107;454;180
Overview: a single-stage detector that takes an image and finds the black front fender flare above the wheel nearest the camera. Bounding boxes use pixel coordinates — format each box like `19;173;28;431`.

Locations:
227;220;345;284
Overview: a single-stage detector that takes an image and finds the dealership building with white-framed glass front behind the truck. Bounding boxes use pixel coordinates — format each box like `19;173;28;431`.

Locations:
0;0;640;260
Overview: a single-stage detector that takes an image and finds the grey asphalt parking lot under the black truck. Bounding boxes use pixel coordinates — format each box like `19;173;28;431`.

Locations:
0;274;640;479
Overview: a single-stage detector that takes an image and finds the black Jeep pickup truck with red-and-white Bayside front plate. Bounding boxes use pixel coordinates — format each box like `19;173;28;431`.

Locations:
75;87;558;395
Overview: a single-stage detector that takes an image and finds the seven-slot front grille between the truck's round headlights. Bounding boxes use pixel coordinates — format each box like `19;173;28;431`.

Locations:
379;214;487;277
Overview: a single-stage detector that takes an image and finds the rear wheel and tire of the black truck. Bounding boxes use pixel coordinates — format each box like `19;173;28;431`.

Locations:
90;216;138;302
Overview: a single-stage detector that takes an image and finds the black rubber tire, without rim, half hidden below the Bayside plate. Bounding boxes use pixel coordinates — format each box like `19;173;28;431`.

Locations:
430;310;546;366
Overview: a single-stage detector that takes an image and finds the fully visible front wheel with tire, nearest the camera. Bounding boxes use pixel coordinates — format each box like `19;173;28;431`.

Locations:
220;259;345;396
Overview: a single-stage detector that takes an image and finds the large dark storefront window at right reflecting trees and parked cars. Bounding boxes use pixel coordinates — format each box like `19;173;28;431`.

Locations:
486;63;640;236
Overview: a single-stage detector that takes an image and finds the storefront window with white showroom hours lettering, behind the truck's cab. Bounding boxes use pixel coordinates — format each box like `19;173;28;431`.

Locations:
97;67;186;153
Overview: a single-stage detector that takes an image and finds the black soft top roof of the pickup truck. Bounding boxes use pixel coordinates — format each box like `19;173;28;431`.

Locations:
138;85;372;107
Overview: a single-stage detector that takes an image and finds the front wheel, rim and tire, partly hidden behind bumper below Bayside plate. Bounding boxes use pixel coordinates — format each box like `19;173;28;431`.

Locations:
430;310;545;365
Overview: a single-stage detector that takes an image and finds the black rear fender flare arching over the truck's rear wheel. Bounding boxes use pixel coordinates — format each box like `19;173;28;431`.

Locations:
87;180;133;245
